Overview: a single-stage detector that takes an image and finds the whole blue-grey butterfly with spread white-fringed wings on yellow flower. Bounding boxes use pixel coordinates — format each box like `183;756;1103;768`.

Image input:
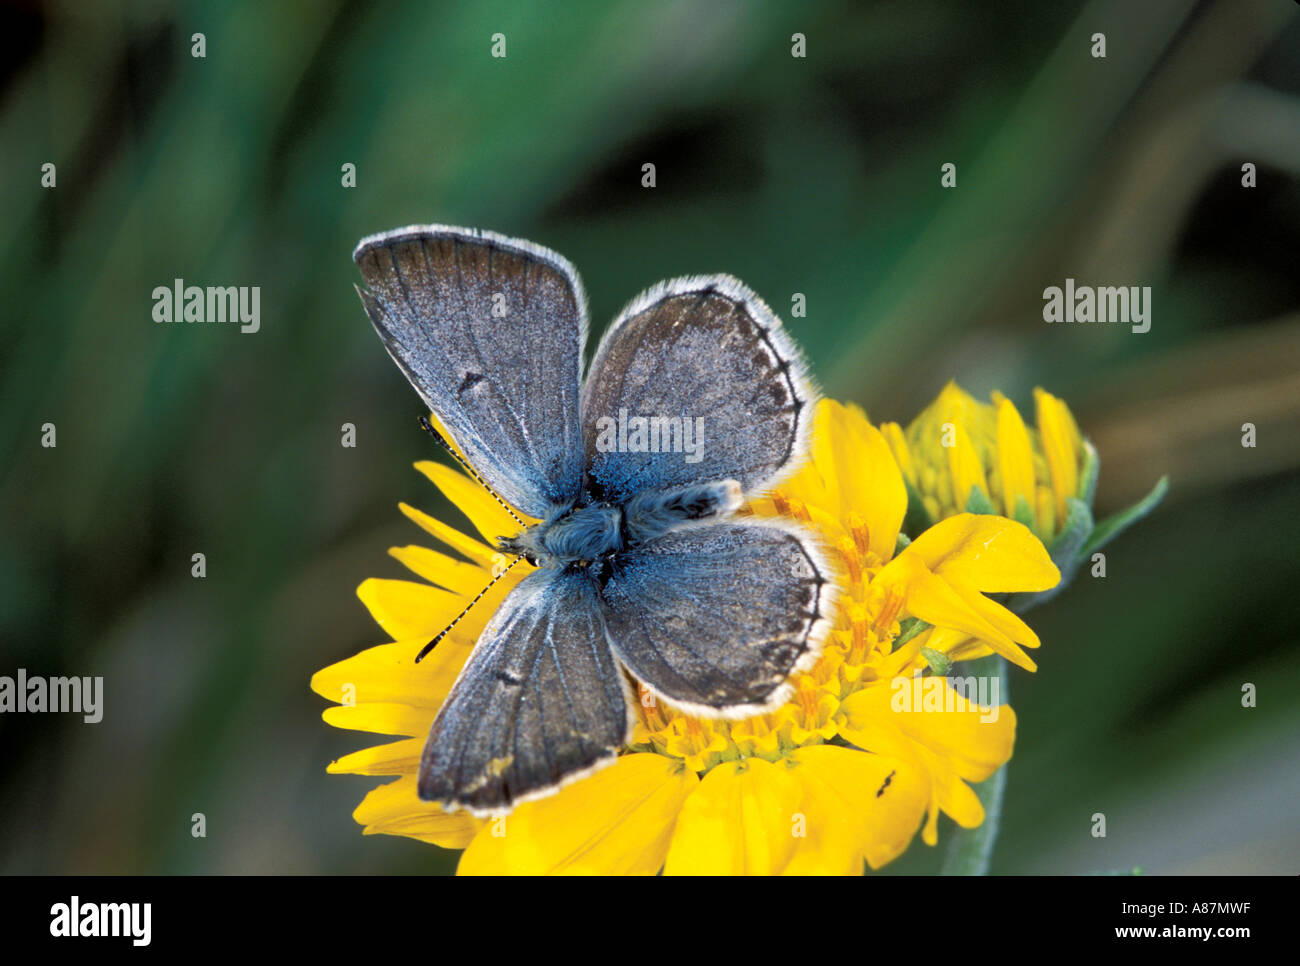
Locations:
352;225;835;816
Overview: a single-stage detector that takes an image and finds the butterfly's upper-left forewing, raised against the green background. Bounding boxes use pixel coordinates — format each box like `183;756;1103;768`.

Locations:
352;225;586;517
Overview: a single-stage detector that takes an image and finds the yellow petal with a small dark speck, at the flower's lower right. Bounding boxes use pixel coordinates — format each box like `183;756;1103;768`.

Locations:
785;745;930;875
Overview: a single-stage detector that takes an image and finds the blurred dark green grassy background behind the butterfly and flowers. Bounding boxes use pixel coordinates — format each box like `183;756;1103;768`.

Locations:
0;0;1300;874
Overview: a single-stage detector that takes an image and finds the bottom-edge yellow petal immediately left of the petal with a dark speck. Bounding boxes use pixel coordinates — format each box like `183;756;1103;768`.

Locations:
664;758;801;875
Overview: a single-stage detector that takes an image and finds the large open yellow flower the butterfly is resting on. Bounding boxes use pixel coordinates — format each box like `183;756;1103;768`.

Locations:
312;400;1060;874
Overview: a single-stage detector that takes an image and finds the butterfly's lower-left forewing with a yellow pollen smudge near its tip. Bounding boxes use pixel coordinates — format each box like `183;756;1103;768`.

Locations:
417;569;631;815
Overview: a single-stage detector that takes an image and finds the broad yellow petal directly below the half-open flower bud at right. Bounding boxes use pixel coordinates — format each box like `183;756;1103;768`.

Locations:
904;514;1061;593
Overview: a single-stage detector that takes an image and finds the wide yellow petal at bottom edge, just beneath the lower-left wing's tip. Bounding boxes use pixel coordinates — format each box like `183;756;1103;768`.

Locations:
459;753;698;875
